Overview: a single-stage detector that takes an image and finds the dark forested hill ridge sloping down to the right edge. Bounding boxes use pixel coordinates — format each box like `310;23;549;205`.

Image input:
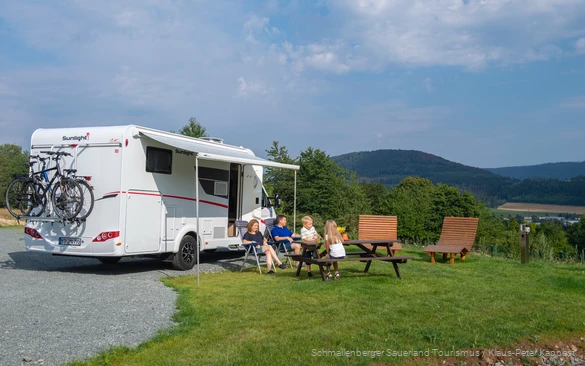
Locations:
332;150;585;207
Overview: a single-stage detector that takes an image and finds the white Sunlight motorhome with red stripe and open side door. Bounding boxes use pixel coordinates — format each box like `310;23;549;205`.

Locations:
24;125;299;270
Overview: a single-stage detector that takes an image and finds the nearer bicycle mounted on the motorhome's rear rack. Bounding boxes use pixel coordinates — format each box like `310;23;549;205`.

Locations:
5;151;83;219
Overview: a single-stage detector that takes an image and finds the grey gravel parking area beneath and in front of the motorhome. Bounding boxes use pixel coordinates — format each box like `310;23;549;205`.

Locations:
0;229;242;365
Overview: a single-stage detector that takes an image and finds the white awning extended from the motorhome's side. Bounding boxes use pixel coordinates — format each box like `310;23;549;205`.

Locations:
140;130;299;170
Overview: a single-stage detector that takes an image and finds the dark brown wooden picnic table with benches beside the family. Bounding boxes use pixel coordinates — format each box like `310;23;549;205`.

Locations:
292;239;414;281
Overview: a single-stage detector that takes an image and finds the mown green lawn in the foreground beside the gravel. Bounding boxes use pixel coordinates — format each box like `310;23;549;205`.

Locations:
67;248;585;365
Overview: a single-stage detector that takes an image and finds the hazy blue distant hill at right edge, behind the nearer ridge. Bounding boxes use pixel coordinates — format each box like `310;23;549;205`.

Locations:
485;161;585;180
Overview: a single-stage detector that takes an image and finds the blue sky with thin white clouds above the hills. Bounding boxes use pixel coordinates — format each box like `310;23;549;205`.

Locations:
0;0;585;167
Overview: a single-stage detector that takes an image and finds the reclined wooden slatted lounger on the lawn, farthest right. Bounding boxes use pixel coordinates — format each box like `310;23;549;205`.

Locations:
423;216;479;264
